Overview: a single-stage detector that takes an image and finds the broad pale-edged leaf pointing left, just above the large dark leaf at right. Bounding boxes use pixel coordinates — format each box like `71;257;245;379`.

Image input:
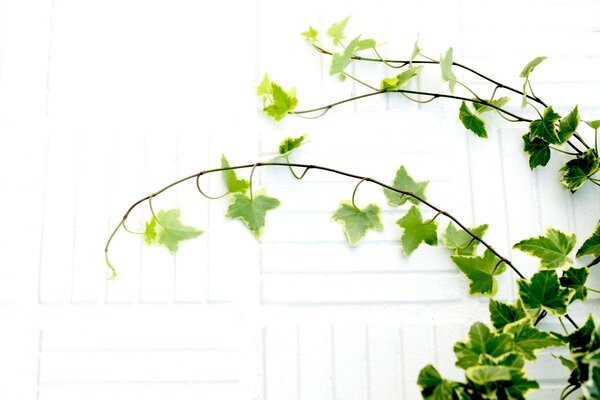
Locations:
513;228;577;269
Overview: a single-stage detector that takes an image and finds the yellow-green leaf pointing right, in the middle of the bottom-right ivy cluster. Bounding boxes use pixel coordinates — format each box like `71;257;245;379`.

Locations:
504;318;563;360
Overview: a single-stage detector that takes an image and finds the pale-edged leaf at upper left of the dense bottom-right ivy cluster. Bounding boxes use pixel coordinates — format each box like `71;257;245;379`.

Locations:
454;322;513;369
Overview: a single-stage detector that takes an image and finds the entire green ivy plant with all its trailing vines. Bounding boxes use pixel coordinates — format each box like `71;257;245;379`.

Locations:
105;18;600;399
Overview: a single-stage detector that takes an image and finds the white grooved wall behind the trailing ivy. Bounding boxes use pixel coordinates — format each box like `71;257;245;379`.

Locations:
0;0;600;400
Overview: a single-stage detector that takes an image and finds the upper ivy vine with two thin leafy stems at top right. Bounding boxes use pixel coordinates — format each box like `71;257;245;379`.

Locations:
257;18;600;192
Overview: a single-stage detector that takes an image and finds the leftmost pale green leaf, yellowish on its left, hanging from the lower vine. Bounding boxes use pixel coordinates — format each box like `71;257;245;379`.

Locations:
144;208;204;254
